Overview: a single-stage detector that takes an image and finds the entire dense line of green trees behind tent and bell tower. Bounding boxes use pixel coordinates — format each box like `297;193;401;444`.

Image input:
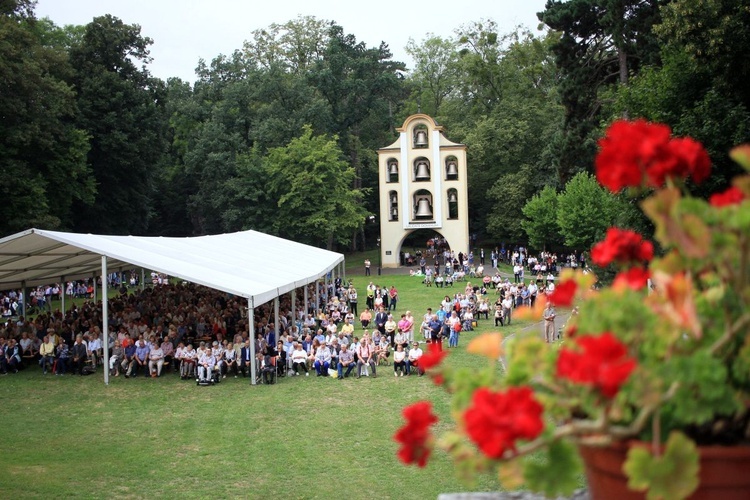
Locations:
0;0;750;249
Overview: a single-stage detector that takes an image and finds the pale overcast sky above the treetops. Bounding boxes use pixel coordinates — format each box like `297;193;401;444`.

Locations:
36;0;546;82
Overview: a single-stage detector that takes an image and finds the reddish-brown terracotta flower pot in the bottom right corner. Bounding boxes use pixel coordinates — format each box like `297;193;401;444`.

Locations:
578;443;750;500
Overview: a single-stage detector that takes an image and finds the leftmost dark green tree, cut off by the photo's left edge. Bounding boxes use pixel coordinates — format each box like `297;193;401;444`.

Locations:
0;1;96;234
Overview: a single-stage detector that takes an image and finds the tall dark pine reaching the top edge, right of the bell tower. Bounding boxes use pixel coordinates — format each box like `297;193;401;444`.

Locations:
537;0;661;183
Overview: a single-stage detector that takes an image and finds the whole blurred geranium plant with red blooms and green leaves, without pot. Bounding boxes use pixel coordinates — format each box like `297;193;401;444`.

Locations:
399;120;750;498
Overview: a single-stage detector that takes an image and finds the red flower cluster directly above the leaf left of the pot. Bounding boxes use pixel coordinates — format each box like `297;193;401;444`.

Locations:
464;387;544;458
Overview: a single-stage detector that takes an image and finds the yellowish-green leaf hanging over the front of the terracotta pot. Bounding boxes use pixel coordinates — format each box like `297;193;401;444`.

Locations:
623;431;699;499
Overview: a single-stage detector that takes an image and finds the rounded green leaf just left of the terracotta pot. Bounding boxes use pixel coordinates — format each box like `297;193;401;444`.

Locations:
524;439;581;496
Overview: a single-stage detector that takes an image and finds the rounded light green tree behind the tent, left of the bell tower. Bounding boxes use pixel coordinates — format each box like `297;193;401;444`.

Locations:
265;126;367;250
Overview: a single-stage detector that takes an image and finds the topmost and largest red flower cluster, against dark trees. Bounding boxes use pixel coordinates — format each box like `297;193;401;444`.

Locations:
596;120;711;193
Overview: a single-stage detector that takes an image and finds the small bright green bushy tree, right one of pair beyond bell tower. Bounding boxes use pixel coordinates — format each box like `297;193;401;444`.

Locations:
557;172;628;251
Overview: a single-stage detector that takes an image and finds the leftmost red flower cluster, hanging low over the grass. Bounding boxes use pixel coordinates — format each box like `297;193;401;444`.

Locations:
393;401;438;467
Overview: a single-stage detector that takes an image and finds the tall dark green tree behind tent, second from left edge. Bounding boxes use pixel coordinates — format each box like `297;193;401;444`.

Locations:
70;15;167;234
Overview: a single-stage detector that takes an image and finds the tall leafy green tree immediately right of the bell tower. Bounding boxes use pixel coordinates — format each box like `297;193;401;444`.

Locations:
444;23;562;242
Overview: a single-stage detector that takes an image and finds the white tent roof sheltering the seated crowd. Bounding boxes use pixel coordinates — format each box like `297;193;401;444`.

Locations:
0;229;344;306
